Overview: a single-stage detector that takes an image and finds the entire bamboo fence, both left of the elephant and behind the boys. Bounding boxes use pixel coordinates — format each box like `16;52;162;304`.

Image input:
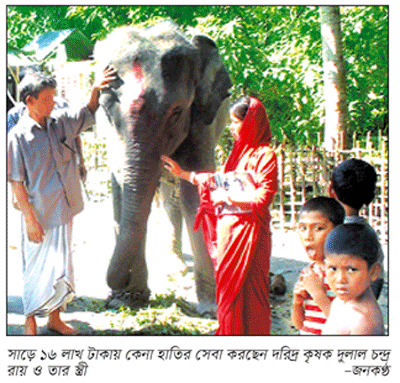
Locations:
82;132;389;244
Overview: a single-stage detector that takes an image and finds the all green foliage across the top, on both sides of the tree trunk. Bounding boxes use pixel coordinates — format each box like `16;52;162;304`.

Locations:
8;5;388;152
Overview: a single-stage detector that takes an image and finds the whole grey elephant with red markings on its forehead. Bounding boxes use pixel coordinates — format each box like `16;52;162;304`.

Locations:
95;22;232;313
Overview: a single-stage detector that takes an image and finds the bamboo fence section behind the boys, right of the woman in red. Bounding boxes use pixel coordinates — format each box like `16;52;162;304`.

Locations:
271;135;389;244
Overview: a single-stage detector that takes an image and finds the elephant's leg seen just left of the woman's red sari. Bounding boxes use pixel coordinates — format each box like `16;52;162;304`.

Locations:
181;181;217;318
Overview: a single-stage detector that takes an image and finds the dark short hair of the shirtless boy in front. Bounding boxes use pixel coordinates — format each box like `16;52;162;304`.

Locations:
324;223;380;268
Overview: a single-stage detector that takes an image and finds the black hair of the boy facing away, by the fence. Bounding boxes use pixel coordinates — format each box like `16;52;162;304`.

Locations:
331;158;377;210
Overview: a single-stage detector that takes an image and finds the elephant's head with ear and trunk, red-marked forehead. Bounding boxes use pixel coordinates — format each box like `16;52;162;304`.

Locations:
95;22;231;294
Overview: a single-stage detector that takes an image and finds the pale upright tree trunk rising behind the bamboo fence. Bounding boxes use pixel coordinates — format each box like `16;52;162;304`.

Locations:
320;6;348;151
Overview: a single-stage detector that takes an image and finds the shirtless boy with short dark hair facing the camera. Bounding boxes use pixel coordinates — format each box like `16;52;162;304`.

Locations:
323;224;384;335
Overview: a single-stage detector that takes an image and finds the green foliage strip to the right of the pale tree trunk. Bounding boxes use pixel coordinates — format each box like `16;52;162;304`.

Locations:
342;6;389;137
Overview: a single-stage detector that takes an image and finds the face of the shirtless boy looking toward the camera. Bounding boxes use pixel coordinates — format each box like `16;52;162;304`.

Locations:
325;254;378;302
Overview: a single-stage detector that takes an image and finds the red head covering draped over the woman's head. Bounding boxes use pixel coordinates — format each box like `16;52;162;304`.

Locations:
224;97;271;172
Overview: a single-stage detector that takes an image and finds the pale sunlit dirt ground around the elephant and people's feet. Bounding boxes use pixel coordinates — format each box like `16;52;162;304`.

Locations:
7;192;388;335
